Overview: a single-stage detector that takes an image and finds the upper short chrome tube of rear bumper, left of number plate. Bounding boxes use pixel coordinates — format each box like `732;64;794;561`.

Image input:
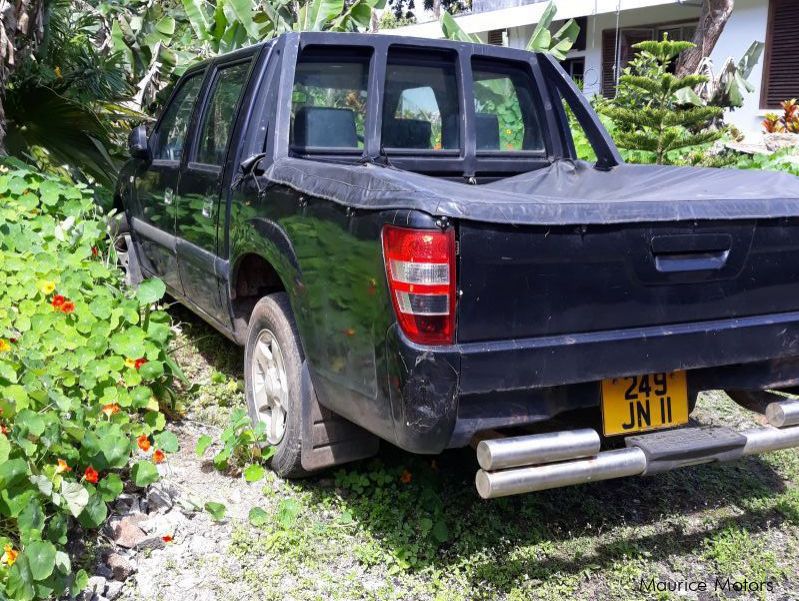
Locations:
477;428;600;471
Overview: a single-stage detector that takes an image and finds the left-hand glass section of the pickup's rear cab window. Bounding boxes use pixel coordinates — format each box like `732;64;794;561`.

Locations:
291;52;369;150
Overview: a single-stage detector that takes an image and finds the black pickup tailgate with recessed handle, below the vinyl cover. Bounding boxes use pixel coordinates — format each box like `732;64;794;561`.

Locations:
457;218;799;342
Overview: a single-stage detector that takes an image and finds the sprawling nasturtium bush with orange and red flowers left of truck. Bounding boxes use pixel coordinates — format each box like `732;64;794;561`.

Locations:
0;163;179;600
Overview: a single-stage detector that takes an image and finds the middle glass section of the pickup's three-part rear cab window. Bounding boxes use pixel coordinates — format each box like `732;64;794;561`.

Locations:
382;50;460;150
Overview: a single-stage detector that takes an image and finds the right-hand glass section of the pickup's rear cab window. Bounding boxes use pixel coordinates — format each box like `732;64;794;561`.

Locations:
472;60;545;152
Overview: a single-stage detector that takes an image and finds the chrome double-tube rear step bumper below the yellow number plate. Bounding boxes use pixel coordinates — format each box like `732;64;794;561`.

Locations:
475;400;799;499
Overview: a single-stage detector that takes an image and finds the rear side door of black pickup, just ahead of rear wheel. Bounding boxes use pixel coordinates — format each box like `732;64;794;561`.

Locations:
176;55;253;326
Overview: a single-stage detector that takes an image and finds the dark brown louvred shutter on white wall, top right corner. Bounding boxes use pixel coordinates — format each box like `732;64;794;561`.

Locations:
760;0;799;109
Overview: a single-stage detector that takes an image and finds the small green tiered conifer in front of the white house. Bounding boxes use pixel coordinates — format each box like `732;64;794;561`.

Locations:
598;34;723;165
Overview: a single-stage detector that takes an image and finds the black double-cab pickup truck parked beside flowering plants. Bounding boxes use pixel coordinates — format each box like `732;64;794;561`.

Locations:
116;33;799;497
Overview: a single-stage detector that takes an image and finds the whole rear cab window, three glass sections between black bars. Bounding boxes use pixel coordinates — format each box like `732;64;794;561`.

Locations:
291;46;546;158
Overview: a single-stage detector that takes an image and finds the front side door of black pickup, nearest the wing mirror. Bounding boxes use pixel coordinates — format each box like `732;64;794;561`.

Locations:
133;71;205;294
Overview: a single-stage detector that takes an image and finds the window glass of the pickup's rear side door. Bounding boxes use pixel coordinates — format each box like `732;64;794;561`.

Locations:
194;62;250;166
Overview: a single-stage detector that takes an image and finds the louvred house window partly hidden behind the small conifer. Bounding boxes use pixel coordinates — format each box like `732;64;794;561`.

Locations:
602;22;696;98
